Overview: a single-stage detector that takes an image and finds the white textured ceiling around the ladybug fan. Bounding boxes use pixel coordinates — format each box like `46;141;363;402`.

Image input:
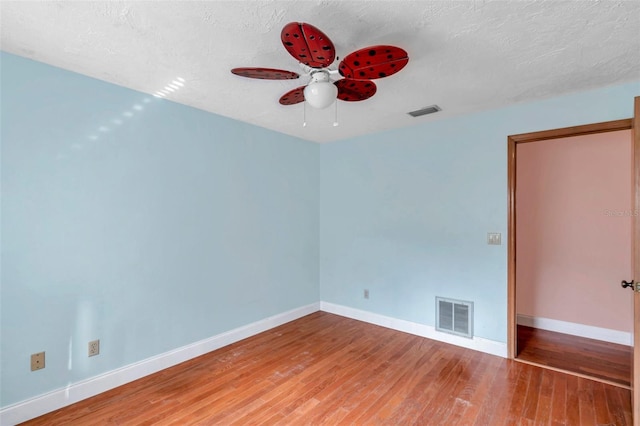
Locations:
0;0;640;142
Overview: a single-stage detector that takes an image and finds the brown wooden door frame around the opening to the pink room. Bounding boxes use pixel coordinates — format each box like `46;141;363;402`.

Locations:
508;119;637;387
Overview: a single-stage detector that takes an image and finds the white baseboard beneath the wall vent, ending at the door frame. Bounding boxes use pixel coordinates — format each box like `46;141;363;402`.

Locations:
320;302;507;358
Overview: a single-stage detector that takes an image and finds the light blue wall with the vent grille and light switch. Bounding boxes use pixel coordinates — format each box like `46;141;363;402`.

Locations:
320;82;640;342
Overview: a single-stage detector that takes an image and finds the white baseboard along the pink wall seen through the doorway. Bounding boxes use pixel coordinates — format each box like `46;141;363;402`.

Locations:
517;314;633;346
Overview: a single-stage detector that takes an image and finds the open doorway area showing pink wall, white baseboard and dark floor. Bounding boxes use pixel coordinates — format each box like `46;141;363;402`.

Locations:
516;130;633;387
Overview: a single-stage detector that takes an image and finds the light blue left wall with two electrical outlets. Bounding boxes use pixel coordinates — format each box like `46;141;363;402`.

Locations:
0;53;319;406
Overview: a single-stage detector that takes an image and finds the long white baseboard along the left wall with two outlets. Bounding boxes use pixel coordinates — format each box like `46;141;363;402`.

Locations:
0;303;320;426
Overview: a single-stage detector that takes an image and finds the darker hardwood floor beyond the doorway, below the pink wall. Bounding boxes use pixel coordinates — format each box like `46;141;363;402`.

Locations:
518;325;631;386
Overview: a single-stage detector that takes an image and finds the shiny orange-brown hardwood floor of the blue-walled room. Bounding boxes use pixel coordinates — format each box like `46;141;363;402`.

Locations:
26;312;632;425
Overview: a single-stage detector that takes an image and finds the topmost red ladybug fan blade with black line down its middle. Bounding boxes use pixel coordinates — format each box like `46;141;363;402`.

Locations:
280;22;336;68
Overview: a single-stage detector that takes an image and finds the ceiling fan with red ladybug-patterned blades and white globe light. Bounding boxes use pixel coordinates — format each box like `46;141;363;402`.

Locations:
231;22;409;108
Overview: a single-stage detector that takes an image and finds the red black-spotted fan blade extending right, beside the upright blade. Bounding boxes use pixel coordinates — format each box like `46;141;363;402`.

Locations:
338;46;409;80
